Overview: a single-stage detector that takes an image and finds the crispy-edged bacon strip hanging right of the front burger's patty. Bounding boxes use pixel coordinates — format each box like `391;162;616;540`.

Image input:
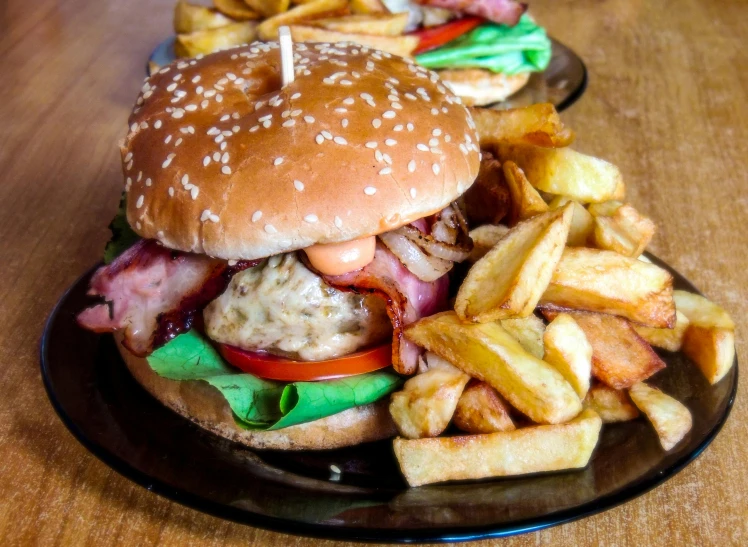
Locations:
322;242;449;374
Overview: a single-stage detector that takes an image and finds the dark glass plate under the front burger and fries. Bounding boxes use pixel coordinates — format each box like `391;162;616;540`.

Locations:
41;261;738;542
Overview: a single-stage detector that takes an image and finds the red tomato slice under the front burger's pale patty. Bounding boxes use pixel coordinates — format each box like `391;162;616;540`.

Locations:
218;344;392;382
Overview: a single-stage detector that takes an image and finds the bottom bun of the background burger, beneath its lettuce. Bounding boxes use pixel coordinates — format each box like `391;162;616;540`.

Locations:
439;68;530;106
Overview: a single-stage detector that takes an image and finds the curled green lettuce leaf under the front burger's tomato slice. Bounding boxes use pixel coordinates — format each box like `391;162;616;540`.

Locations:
148;330;402;430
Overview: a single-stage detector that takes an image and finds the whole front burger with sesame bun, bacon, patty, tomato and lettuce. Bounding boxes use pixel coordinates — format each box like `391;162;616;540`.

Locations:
78;37;481;450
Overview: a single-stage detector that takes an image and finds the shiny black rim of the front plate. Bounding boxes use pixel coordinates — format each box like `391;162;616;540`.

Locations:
39;262;739;543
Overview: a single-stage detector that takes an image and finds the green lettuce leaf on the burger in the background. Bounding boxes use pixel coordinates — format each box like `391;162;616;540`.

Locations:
416;15;552;75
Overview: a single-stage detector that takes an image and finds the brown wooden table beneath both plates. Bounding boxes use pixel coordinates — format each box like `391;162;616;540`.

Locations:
0;0;748;546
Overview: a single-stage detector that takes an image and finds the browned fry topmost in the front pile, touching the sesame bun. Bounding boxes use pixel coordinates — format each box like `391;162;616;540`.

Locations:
470;103;574;148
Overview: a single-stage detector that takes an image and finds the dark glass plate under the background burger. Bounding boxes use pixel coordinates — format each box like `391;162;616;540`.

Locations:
146;36;587;112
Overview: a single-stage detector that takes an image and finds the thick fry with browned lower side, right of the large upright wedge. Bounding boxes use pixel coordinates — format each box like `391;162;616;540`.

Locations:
536;249;675;328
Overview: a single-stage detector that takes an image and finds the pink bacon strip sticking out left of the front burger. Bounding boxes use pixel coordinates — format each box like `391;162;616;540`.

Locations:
78;240;259;357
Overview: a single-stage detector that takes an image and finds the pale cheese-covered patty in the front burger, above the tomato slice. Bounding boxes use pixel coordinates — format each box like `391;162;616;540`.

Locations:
203;253;392;361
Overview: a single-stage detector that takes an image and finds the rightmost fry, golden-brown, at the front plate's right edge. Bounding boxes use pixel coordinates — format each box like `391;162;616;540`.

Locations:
673;291;735;384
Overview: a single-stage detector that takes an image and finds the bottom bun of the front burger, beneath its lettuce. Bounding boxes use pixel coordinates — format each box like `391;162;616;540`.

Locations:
117;339;396;450
